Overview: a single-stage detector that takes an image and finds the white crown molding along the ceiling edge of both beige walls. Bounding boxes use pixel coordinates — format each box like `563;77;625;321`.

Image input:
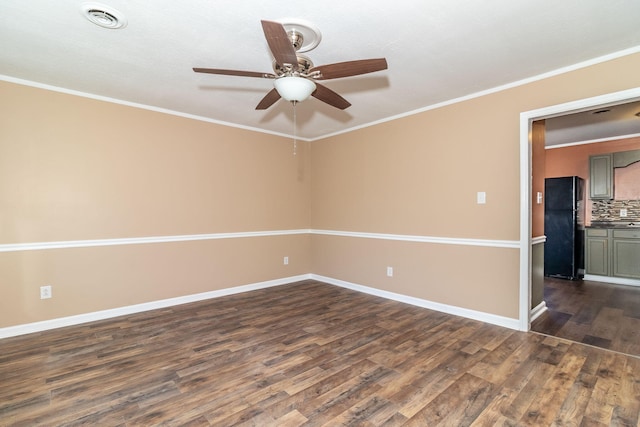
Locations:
0;46;640;142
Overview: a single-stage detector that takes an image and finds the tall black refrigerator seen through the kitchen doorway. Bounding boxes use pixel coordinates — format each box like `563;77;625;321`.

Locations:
544;176;584;280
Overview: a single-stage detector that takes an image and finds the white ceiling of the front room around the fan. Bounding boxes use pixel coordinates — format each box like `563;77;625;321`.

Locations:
0;0;640;139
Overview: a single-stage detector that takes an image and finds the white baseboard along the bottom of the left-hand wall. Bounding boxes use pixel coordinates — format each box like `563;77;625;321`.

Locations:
0;274;311;338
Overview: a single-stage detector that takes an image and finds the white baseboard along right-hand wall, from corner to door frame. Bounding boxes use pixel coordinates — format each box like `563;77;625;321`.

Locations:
311;274;519;329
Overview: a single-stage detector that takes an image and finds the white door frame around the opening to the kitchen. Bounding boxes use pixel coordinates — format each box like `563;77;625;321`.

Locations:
518;87;640;331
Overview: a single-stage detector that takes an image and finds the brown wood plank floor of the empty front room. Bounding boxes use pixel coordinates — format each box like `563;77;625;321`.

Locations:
0;281;640;426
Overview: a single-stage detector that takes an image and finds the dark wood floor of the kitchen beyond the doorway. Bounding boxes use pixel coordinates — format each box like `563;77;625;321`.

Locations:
531;277;640;357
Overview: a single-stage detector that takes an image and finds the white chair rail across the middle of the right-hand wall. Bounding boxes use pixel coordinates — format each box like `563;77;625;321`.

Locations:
311;230;518;249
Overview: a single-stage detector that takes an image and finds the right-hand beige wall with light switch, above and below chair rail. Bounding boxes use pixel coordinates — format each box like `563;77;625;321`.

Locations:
311;51;640;318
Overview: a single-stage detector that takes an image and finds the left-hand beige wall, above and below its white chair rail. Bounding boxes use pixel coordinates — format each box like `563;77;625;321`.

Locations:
0;82;310;327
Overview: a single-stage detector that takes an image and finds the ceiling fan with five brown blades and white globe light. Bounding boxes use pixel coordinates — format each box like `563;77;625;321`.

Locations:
193;21;387;110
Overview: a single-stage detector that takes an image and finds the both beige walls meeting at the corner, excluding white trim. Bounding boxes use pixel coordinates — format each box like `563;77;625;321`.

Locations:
0;51;640;327
